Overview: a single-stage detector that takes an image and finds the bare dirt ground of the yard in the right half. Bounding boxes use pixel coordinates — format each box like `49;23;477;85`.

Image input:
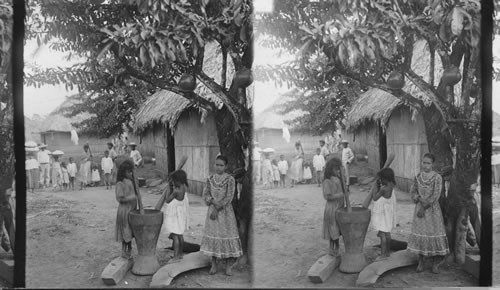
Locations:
254;174;478;288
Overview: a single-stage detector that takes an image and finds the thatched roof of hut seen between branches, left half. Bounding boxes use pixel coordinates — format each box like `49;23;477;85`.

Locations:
134;42;249;132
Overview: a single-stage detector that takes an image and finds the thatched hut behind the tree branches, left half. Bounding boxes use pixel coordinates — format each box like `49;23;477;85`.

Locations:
134;43;249;195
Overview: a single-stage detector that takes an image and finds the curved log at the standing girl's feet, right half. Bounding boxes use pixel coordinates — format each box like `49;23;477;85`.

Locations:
356;250;418;287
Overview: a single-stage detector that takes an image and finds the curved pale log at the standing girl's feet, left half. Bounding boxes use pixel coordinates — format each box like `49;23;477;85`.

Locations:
150;252;211;287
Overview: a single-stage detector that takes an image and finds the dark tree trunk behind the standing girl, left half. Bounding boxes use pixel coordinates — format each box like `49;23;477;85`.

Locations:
214;106;253;257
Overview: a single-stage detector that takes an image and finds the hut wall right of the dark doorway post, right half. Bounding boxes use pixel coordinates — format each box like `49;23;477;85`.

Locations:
387;107;428;191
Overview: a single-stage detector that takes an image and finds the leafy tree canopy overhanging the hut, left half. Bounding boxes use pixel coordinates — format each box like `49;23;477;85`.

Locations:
25;0;252;139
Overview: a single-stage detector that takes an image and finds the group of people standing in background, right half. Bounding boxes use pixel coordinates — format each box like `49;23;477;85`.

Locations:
252;138;354;188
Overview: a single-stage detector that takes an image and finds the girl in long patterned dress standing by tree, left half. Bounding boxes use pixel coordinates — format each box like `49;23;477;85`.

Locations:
200;155;243;276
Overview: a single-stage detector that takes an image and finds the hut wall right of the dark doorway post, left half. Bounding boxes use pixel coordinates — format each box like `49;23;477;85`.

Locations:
174;110;219;194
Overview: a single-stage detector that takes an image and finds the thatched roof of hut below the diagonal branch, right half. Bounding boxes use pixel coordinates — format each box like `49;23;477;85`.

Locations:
346;88;402;131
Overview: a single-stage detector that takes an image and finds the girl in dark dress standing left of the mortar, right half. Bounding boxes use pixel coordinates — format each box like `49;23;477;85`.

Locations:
323;158;344;256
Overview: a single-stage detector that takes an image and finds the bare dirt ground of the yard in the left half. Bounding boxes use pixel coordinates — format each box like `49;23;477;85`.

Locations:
26;182;252;288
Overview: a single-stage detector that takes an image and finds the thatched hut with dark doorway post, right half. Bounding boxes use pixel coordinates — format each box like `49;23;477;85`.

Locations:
342;88;429;191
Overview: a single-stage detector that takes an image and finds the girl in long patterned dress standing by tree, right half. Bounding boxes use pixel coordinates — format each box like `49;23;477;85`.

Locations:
408;153;449;274
